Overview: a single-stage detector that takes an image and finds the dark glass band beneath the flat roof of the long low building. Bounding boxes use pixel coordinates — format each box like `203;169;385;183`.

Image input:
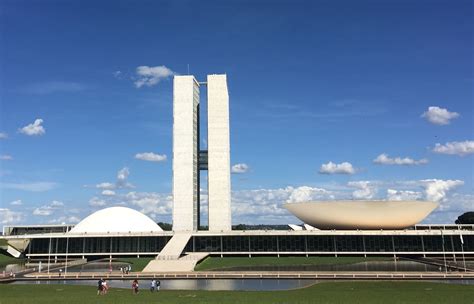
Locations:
26;235;474;254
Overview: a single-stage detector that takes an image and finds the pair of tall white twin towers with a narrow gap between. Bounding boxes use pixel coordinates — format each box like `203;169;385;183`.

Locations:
173;75;232;231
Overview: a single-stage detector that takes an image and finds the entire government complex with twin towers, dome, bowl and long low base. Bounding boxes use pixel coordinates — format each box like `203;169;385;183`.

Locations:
2;75;474;270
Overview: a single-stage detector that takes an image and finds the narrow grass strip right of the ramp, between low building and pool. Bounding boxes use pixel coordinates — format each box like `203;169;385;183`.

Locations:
195;257;390;271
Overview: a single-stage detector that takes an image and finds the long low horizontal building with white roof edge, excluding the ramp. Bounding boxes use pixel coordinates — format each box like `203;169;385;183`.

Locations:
5;226;474;258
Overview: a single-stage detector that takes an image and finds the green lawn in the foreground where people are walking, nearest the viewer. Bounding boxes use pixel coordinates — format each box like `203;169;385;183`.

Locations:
0;281;474;304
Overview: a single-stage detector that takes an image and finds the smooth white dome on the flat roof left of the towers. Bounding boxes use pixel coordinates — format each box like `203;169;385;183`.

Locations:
69;207;163;233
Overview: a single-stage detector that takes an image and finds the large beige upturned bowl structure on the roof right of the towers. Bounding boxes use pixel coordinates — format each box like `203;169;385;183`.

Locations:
284;201;438;230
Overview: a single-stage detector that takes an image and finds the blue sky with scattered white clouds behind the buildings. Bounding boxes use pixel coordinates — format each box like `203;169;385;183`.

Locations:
0;0;474;224
